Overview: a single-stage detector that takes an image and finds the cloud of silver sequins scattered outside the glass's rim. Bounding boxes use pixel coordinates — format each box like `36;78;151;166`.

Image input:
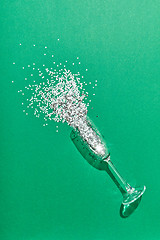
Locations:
12;43;97;134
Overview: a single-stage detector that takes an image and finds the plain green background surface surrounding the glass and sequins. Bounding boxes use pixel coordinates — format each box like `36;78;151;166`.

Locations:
0;0;160;240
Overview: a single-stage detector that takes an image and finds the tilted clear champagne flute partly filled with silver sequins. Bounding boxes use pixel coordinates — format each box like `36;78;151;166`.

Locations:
70;116;146;218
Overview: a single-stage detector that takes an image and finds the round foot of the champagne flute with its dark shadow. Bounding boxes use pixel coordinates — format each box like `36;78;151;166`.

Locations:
120;186;146;218
